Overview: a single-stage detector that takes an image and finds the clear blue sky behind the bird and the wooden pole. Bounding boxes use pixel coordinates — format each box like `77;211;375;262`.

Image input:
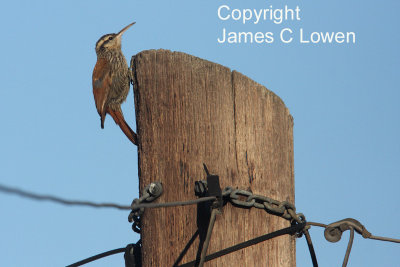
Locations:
0;0;400;266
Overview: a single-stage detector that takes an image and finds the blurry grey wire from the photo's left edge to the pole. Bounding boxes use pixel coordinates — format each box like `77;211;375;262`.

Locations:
0;184;131;210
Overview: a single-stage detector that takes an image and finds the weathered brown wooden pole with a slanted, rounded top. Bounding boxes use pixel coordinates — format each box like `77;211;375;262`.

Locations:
133;50;296;267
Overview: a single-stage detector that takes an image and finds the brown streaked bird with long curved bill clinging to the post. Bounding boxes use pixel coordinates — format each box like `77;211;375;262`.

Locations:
92;22;138;145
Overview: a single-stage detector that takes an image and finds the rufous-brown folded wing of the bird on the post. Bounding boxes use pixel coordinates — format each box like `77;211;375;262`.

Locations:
92;58;112;128
